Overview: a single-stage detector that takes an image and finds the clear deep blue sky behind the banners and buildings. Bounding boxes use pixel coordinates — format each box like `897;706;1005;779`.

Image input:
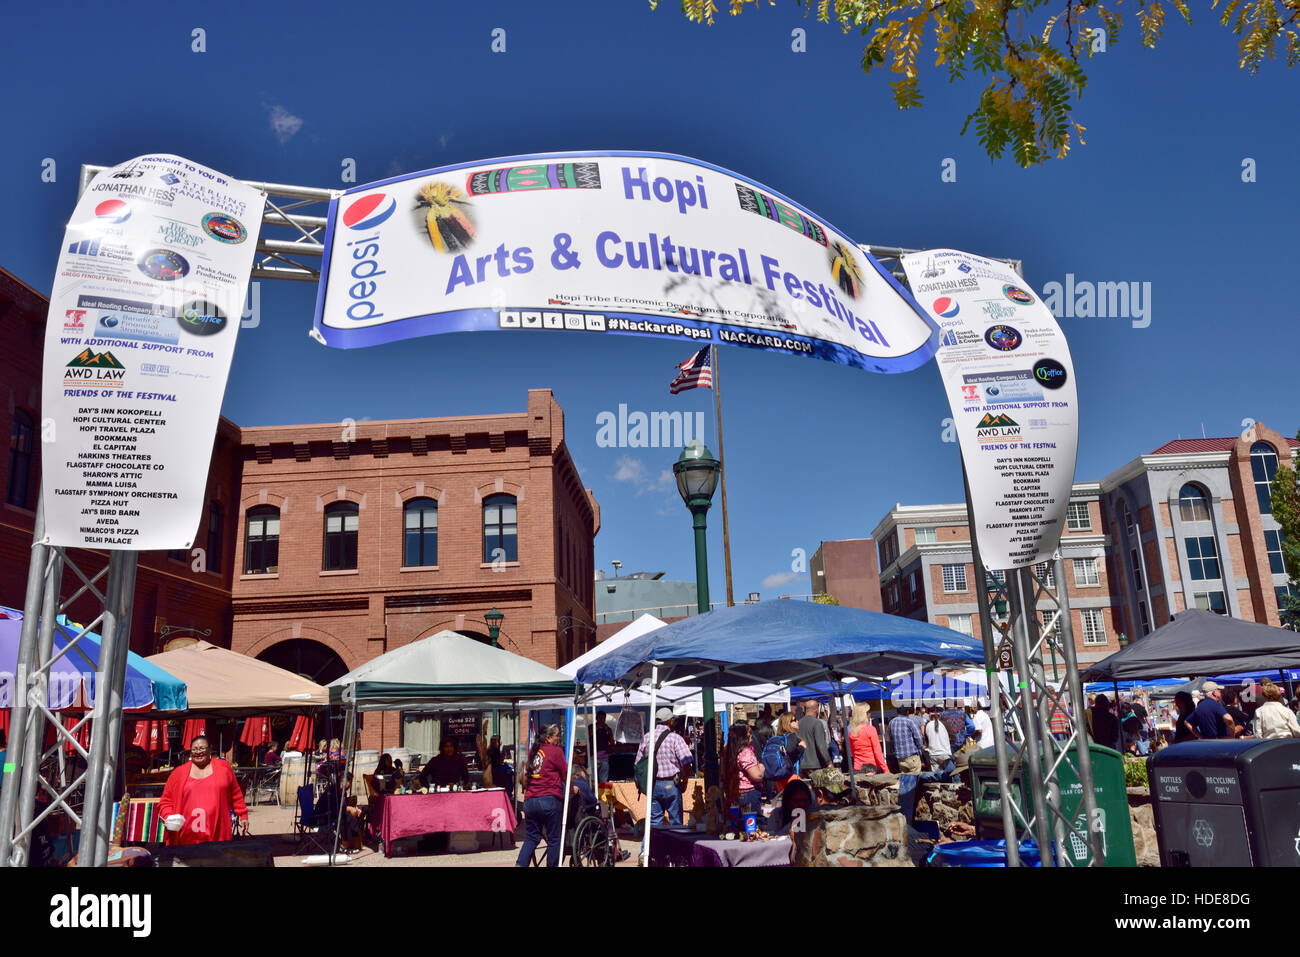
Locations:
0;0;1300;599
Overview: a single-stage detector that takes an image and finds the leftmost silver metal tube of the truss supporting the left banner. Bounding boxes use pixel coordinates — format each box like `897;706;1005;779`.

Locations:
0;495;49;867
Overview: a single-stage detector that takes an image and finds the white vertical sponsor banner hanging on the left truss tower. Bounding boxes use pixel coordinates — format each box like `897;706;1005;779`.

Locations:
42;153;263;550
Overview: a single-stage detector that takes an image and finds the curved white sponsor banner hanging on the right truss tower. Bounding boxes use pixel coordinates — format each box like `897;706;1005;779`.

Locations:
902;250;1079;568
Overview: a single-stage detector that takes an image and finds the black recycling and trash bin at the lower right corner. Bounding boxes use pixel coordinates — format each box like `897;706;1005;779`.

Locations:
1147;739;1300;867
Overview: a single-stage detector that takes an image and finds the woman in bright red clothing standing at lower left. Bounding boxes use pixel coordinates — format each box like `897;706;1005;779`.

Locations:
159;735;248;845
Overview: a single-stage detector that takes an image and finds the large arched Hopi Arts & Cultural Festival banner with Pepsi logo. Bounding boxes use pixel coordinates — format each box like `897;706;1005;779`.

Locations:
315;152;939;372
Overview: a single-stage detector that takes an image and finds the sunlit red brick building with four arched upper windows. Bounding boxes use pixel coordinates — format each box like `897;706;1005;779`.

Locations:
230;389;601;746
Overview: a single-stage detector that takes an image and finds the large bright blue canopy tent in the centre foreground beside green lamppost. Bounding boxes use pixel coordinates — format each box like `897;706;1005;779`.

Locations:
577;601;984;865
